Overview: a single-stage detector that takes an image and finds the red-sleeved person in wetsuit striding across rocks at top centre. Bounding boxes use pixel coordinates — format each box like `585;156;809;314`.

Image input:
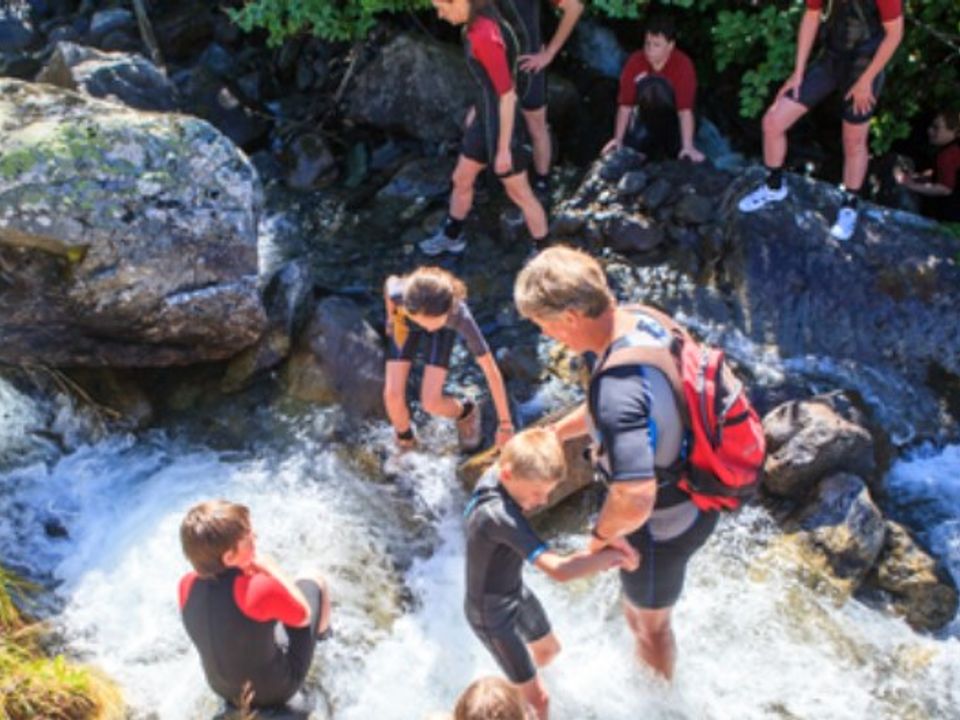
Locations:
420;0;548;255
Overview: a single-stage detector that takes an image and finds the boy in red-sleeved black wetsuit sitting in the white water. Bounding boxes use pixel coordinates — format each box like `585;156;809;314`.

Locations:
179;500;330;708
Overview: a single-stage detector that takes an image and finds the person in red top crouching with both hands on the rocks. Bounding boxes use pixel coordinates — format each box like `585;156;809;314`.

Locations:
603;16;703;162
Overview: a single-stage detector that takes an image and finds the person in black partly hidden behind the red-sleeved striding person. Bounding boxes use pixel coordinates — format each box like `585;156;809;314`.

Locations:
497;0;583;200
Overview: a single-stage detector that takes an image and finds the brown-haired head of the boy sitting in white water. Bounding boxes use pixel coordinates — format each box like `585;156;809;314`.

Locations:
180;500;251;577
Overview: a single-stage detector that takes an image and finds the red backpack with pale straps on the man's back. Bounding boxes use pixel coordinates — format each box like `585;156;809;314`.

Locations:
593;305;766;510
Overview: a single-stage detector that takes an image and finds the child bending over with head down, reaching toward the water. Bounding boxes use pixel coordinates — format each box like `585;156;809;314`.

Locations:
383;267;513;451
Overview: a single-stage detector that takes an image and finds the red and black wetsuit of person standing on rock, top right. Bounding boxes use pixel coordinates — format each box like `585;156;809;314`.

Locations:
795;0;903;124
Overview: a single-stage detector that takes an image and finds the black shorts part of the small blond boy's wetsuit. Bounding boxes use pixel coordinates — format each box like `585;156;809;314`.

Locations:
470;585;550;684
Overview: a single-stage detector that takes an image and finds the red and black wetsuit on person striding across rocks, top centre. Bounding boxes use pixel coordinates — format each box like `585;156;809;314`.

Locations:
460;9;530;175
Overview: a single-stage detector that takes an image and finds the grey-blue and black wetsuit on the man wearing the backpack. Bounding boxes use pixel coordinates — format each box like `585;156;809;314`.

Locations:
588;314;719;609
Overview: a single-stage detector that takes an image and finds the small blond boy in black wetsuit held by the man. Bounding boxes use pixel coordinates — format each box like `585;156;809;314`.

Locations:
464;428;637;720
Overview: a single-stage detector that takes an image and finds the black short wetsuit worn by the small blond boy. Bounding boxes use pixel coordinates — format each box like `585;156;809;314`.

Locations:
464;466;550;683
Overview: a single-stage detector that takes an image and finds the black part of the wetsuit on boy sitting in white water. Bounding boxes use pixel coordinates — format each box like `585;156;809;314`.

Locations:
181;569;321;707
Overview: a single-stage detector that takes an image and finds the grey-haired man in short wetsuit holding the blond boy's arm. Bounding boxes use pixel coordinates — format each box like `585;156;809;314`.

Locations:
514;247;718;679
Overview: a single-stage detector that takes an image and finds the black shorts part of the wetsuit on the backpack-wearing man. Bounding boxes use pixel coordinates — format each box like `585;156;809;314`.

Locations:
620;512;720;610
